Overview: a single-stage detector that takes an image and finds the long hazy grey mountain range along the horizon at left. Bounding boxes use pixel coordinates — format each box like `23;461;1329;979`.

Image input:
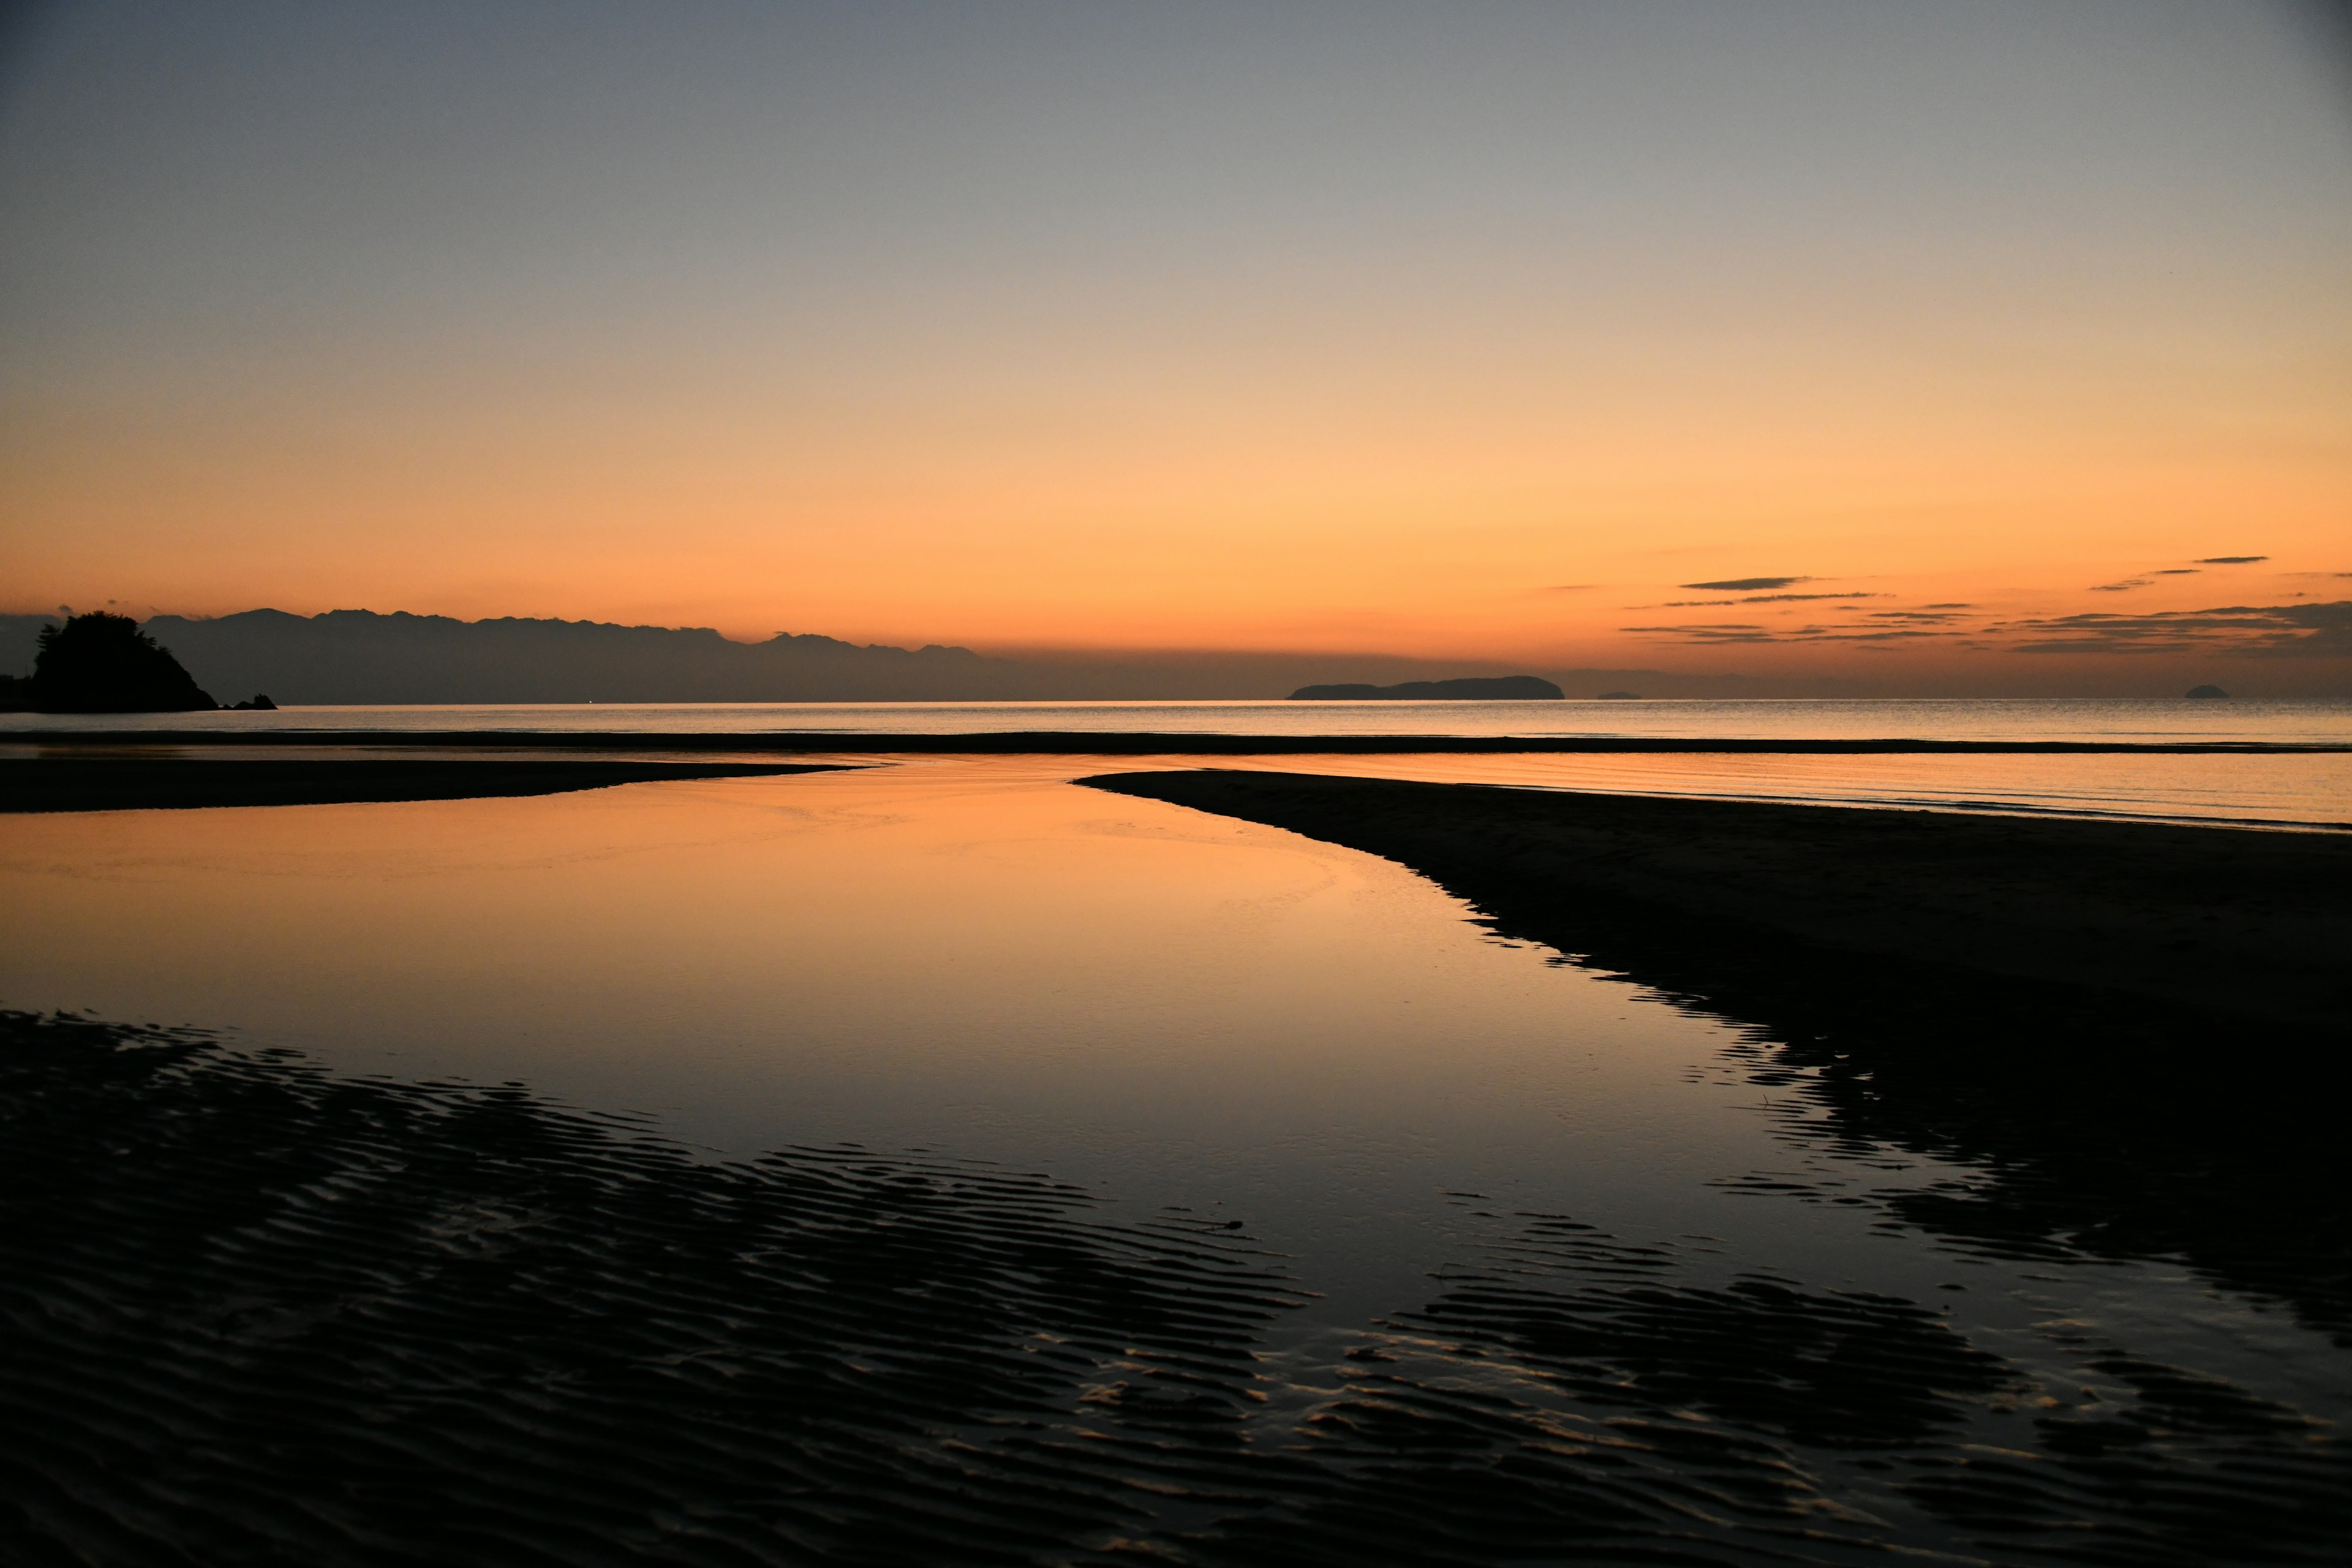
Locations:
0;609;1860;705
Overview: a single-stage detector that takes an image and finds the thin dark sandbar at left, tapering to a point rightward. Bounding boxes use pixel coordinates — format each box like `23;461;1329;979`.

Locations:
0;757;846;811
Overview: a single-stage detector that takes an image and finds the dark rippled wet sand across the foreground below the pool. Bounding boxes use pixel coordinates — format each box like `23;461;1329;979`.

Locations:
0;1013;2352;1563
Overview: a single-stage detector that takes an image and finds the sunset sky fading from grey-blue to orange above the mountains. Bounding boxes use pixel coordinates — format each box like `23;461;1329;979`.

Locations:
0;0;2352;693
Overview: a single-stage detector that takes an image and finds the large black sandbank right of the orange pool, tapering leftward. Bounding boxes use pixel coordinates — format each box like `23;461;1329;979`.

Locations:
1080;771;2352;1347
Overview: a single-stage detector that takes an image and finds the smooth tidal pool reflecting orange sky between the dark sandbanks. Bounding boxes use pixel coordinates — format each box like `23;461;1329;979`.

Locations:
0;760;2352;1540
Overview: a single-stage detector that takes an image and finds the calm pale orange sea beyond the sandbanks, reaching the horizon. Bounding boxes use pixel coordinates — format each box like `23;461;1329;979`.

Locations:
0;698;2352;827
